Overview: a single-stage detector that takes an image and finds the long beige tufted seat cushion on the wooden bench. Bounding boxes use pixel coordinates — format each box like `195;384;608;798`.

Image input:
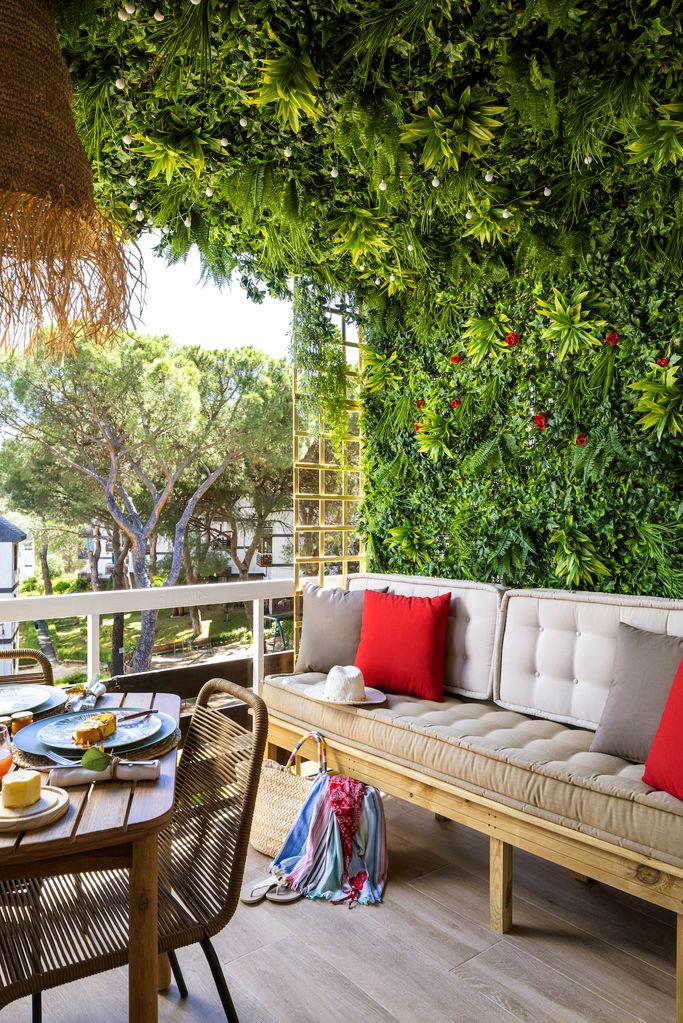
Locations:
262;673;683;866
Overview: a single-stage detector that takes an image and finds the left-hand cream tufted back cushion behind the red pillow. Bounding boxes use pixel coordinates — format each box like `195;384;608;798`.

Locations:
349;573;503;700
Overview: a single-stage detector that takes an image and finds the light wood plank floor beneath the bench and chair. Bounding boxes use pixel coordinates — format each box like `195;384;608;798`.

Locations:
6;799;675;1023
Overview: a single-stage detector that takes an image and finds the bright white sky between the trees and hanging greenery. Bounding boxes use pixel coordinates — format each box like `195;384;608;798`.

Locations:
131;234;291;357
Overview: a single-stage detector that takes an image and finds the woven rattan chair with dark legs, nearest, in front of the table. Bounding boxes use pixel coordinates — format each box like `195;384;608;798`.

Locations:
0;679;268;1023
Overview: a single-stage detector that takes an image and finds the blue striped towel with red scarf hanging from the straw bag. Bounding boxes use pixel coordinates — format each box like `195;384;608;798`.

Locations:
271;774;388;906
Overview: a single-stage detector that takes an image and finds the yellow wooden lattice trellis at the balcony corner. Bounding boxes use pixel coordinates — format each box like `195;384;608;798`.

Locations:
292;315;365;652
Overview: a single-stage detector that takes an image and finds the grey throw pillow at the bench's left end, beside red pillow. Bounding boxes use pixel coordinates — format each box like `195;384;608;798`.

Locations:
294;583;386;671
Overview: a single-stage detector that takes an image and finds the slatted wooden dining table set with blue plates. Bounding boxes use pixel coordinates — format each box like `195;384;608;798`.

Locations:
0;693;180;1023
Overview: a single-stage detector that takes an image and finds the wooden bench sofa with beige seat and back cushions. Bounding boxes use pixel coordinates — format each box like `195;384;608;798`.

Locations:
262;574;683;1023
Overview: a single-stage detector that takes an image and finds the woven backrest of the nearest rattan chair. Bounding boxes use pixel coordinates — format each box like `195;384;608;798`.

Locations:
160;678;268;935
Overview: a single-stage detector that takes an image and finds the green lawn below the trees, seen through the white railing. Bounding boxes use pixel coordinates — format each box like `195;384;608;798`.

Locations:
19;604;251;675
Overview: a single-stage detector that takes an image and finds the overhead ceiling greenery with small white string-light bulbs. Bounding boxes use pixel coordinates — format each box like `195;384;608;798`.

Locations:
54;0;683;304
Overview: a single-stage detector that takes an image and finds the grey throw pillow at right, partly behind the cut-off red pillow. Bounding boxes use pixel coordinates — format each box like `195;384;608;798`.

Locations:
591;622;683;763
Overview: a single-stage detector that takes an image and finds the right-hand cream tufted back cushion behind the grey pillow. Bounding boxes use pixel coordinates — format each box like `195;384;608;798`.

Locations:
494;589;683;729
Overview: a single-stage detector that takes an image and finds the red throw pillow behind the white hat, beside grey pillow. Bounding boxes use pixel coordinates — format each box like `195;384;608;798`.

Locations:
355;589;451;703
